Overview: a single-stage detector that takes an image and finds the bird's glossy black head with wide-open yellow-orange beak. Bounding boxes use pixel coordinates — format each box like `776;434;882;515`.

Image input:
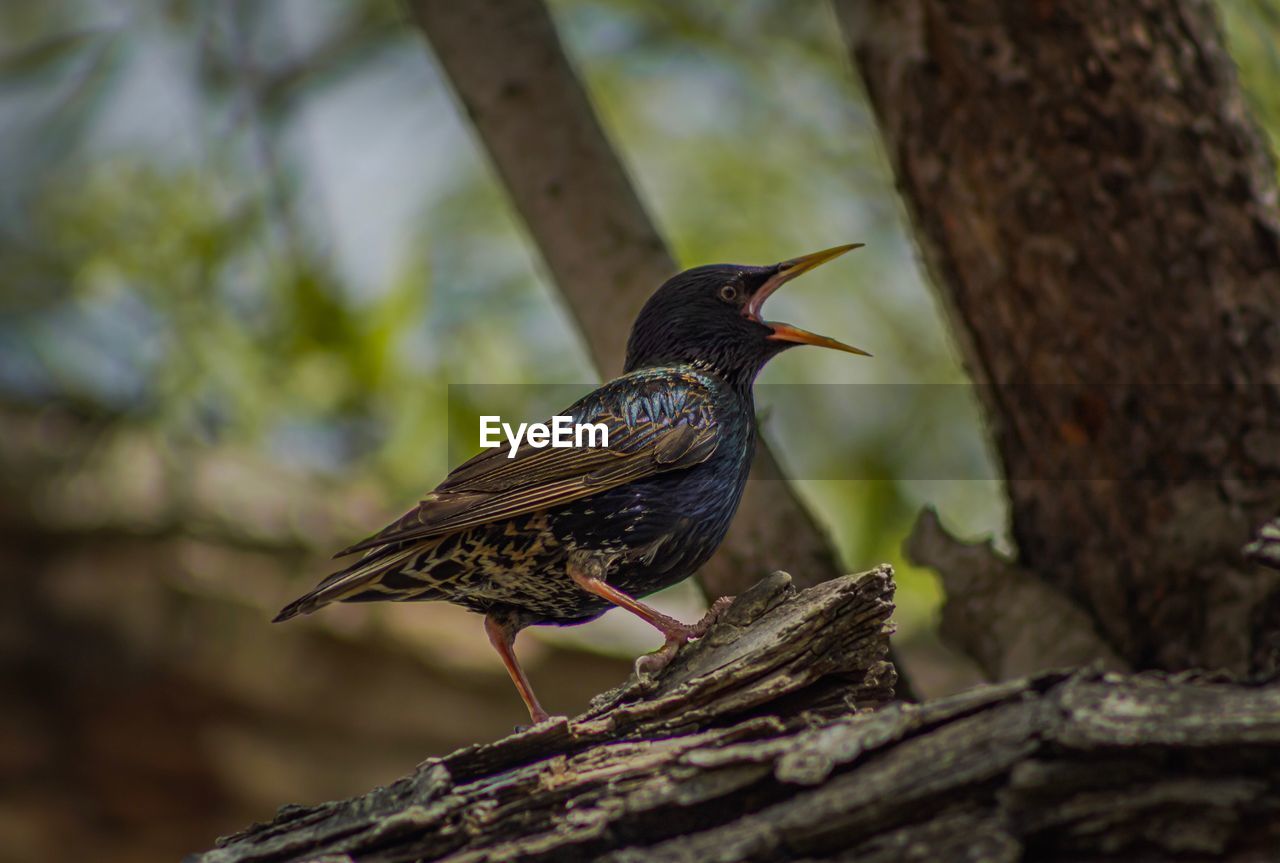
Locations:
626;243;870;387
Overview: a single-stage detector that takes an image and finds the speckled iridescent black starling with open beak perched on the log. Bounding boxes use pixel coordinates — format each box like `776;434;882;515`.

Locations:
275;243;870;726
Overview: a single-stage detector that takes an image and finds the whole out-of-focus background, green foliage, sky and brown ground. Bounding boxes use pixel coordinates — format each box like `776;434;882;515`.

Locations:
0;0;1280;860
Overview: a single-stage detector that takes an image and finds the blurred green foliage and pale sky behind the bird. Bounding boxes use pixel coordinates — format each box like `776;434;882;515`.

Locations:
0;0;1280;645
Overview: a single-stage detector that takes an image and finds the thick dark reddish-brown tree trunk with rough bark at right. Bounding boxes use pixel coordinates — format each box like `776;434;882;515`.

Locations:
836;0;1280;671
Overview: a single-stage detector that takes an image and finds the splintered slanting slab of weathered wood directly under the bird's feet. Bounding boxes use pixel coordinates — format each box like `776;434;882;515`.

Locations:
196;566;895;863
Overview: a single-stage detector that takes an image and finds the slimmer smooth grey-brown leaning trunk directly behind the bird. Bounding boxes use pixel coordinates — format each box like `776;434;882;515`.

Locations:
408;0;840;597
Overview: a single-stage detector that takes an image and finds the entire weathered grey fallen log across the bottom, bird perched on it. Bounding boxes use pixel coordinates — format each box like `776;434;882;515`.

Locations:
188;567;1280;863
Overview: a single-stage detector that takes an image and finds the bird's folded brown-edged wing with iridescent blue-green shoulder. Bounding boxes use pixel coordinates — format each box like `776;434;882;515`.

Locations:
337;371;719;557
